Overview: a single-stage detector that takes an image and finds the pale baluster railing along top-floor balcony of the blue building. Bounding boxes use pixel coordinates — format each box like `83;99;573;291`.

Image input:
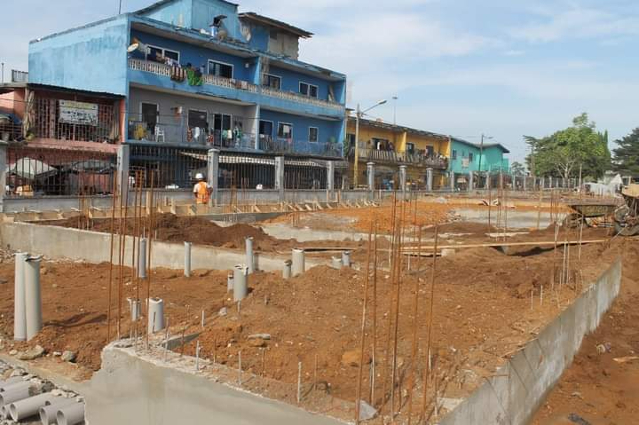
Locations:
129;59;344;110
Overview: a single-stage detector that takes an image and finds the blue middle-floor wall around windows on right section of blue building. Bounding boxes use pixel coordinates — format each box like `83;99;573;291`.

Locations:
260;106;342;146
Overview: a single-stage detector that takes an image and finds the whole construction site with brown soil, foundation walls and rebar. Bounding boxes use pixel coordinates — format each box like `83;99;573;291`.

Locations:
0;176;639;425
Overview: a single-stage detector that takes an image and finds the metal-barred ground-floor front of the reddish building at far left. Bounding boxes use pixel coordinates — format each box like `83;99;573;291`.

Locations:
6;144;117;197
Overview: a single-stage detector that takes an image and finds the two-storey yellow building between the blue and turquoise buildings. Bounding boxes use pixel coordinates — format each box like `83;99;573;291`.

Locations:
345;117;451;189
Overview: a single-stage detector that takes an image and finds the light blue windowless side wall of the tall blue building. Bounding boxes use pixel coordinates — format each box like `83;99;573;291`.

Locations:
29;15;129;95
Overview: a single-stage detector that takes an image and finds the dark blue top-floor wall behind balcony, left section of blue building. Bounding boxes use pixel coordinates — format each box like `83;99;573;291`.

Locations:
131;30;258;81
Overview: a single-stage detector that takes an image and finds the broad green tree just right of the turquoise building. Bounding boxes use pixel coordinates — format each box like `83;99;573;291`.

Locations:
524;113;610;179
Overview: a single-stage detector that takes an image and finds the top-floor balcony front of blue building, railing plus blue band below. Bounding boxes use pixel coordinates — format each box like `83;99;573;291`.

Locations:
129;59;344;116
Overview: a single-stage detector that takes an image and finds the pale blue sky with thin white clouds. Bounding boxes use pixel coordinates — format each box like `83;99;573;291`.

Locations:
0;0;639;161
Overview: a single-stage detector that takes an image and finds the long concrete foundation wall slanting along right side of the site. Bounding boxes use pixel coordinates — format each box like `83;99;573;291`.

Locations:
439;260;621;425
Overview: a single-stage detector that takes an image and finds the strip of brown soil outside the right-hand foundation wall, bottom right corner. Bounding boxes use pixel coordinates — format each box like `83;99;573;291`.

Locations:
533;239;639;425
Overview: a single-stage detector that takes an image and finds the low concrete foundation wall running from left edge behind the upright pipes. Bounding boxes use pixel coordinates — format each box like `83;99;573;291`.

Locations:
0;223;324;271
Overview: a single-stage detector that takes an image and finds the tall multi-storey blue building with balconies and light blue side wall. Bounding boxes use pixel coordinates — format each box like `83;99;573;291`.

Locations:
29;0;346;184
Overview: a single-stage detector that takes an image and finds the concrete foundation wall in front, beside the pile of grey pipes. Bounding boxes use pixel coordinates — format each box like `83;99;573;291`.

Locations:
83;347;341;425
